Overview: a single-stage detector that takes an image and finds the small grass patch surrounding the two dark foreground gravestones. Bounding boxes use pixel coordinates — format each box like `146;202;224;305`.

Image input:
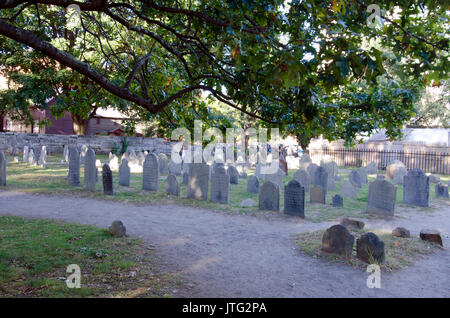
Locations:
294;230;438;272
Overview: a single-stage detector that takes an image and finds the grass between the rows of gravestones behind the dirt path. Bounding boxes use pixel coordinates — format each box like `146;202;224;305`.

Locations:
6;155;449;222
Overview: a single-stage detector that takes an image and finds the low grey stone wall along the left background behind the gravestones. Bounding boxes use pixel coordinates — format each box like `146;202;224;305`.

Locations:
0;132;174;155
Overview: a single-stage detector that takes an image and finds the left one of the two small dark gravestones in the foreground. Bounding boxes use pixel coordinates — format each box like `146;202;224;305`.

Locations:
322;224;355;257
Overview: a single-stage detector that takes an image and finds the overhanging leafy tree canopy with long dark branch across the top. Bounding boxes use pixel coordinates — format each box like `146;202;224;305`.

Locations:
0;0;449;143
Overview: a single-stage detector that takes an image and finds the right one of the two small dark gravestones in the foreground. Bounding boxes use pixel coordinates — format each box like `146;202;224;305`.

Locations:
356;232;385;264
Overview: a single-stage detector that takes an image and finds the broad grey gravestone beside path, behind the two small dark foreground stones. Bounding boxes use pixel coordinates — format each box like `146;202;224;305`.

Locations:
366;180;397;216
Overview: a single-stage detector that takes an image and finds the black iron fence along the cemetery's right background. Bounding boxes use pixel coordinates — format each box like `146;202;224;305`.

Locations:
309;147;450;174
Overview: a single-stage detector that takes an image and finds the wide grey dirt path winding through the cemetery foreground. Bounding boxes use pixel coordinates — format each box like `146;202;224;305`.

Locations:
0;191;450;297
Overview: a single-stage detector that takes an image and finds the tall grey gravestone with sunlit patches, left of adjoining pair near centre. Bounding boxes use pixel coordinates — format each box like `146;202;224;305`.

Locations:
187;163;209;201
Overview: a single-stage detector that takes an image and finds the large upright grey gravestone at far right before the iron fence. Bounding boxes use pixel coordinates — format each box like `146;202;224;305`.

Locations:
403;168;430;207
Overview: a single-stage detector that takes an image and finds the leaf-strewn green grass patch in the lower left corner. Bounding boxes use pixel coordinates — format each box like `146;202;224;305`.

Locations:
0;216;179;297
